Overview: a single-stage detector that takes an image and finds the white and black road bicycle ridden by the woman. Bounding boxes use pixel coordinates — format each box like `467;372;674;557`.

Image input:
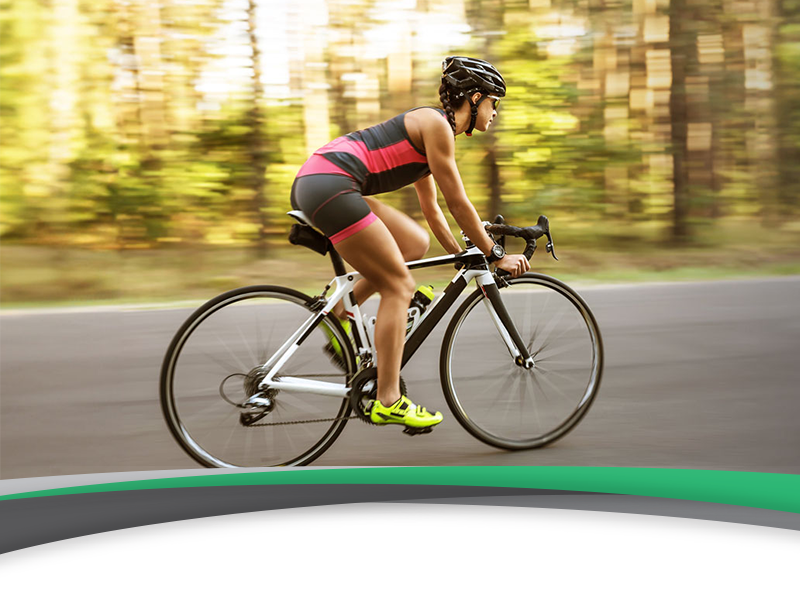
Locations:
160;211;603;467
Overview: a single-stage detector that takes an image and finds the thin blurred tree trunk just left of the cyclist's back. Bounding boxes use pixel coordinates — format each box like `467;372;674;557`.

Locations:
246;0;269;256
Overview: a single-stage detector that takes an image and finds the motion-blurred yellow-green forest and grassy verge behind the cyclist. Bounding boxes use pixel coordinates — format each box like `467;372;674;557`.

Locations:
0;0;800;304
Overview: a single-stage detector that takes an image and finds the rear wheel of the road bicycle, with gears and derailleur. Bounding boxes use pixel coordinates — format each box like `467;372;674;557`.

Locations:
160;286;355;467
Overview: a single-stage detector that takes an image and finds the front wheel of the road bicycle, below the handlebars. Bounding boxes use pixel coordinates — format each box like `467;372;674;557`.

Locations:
439;273;603;450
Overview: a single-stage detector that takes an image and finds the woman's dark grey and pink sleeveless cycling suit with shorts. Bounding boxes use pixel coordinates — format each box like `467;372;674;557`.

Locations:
291;107;447;244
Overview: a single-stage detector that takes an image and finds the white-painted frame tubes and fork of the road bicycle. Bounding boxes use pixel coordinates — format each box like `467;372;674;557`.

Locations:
253;248;520;398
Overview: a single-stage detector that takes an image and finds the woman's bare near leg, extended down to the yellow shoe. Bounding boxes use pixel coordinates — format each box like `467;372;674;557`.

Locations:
336;219;415;406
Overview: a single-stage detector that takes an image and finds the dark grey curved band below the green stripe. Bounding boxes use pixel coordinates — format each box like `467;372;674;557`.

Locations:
0;484;800;553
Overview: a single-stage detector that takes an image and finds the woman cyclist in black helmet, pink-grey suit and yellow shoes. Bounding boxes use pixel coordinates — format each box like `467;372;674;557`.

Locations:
291;56;530;428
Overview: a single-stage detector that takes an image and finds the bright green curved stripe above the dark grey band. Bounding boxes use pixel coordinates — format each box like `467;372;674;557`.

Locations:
0;467;800;513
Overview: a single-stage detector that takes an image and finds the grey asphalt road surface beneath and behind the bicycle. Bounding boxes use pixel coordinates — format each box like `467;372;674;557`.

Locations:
0;277;800;479
